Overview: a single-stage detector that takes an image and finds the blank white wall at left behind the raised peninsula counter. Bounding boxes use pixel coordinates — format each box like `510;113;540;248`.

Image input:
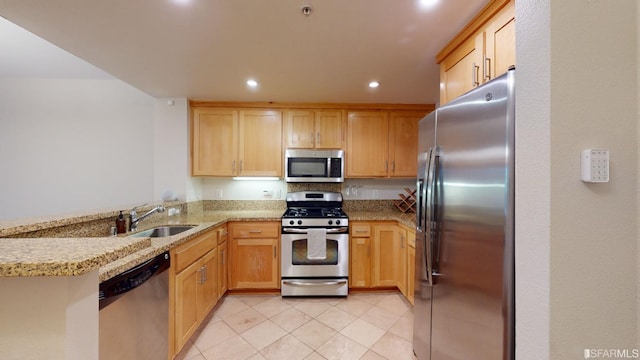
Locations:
0;78;154;220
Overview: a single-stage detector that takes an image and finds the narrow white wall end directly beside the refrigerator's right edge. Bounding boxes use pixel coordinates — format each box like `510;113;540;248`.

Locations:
515;0;552;360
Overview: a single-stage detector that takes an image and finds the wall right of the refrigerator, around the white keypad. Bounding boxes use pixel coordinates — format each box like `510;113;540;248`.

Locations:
516;0;638;360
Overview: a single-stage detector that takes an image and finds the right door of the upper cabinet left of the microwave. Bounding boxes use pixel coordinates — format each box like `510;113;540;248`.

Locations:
238;110;284;177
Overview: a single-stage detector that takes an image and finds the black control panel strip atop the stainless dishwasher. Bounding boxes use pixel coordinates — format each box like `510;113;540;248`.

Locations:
98;252;171;309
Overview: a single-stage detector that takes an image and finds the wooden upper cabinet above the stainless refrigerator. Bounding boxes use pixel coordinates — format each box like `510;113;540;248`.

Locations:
436;0;516;104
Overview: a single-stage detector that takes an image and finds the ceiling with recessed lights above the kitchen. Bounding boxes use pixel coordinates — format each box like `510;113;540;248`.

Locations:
0;0;488;103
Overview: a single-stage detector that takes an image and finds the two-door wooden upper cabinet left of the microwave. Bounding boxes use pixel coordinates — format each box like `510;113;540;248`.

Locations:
192;108;282;177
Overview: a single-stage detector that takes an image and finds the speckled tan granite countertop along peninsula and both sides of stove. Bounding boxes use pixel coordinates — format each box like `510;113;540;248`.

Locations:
0;210;415;281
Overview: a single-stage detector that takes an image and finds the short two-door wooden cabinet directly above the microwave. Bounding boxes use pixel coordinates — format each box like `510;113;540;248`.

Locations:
284;110;344;149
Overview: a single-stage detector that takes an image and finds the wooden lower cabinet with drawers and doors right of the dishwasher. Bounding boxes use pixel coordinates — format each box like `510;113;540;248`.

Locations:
169;231;218;355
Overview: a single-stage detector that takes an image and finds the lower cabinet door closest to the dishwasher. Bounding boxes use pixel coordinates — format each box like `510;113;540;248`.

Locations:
175;261;202;352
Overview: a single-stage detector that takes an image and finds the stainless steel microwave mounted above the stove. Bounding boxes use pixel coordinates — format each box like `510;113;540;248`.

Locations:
284;149;344;182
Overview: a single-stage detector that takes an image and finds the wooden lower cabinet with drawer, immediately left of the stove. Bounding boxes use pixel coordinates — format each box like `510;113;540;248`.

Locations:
229;222;280;290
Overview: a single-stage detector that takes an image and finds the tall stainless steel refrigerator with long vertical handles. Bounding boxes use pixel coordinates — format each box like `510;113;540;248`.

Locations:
413;69;515;360
